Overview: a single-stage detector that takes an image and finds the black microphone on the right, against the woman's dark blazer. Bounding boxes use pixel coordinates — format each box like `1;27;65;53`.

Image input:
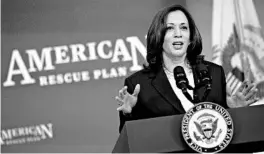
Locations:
196;63;212;101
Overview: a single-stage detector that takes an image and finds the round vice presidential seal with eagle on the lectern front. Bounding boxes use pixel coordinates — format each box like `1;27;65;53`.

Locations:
181;102;234;153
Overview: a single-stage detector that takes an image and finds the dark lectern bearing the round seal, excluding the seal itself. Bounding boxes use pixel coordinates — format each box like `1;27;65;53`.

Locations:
112;105;264;153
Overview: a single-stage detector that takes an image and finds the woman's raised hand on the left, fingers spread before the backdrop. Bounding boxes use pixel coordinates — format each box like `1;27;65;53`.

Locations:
115;84;140;114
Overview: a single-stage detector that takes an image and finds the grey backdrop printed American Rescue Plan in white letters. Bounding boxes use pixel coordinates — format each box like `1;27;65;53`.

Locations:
0;0;185;153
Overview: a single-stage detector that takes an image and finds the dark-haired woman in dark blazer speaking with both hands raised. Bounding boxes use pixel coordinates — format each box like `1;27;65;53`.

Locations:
116;5;255;131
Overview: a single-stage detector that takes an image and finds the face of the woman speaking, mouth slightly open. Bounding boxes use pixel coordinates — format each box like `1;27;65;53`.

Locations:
163;10;190;58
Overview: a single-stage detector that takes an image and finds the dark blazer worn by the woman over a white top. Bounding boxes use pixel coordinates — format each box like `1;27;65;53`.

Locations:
119;61;227;132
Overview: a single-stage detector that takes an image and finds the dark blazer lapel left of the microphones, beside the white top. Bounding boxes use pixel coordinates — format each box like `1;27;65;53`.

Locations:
152;68;185;113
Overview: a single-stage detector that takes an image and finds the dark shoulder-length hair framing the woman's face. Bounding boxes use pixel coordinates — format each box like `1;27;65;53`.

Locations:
146;5;203;71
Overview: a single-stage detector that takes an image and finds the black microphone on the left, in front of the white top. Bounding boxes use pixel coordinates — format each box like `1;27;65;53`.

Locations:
173;66;193;102
